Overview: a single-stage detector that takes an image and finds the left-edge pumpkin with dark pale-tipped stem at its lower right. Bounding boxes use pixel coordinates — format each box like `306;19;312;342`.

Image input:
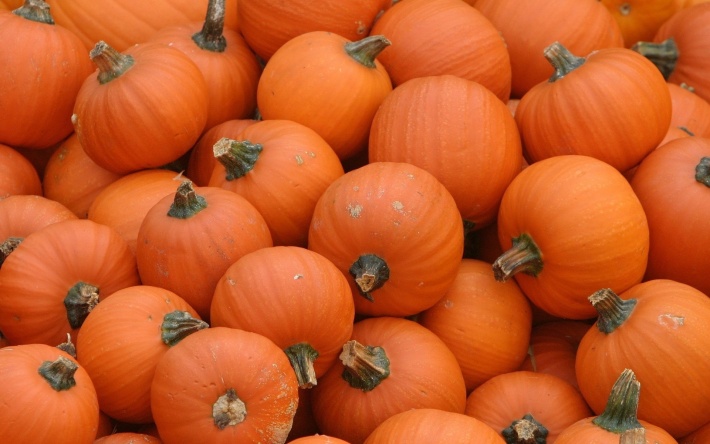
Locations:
0;219;140;345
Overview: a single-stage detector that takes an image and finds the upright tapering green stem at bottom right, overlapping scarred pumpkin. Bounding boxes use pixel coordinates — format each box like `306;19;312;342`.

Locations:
592;368;643;434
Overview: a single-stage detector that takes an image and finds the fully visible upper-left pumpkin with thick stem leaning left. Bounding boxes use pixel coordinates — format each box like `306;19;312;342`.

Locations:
71;41;209;174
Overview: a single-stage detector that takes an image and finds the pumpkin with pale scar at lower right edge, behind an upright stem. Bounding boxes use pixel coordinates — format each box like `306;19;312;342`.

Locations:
576;279;710;437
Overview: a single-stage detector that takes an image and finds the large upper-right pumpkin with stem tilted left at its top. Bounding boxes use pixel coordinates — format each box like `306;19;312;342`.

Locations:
515;41;672;171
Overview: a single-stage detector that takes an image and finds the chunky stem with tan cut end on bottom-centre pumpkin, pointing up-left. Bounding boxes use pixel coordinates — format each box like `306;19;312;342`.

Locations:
340;340;390;392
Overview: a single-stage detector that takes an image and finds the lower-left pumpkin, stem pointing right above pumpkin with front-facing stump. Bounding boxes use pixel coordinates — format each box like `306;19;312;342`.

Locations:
76;285;208;423
